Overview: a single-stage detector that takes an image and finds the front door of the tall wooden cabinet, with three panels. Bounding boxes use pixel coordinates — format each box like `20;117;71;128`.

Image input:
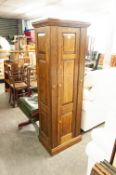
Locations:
58;27;80;144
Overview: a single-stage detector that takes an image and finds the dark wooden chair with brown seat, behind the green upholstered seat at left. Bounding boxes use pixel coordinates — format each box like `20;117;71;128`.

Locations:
8;66;30;107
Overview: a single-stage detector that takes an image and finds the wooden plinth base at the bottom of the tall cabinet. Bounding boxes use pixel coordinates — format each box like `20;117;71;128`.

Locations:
39;135;82;156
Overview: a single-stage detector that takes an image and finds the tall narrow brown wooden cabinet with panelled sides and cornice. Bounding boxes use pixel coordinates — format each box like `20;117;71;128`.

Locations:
33;19;89;155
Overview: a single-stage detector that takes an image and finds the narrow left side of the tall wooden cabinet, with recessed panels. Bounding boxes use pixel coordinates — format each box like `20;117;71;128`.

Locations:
37;27;50;142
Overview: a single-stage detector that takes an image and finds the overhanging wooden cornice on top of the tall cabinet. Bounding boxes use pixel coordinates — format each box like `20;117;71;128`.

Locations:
33;18;90;28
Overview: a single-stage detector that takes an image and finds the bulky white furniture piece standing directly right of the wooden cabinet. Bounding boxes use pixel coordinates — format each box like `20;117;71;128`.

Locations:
81;67;116;131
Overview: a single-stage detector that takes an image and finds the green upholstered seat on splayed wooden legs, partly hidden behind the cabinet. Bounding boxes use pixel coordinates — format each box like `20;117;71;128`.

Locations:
18;94;39;131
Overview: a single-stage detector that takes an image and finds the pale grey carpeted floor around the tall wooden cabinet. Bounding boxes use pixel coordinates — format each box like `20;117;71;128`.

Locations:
0;93;91;175
